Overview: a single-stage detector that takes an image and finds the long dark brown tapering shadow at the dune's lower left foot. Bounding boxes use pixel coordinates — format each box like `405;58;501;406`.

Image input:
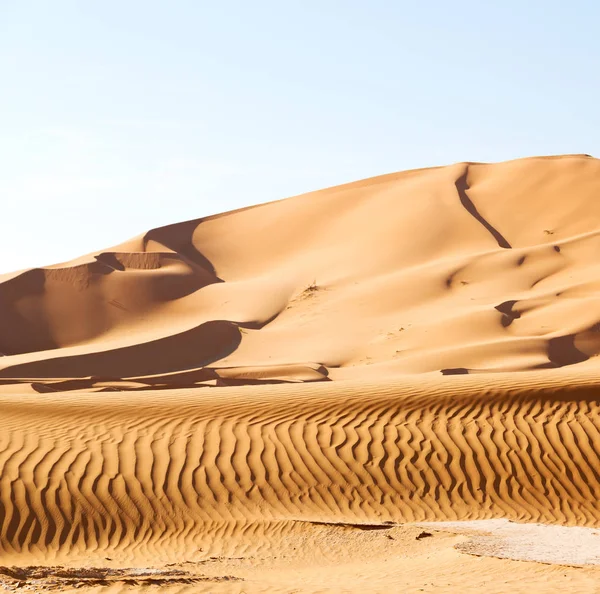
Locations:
0;320;241;378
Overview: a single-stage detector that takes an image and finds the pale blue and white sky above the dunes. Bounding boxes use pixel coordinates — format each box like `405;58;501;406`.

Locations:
0;0;600;273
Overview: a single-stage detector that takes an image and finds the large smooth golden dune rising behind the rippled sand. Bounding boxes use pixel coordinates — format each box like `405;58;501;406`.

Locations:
0;156;600;391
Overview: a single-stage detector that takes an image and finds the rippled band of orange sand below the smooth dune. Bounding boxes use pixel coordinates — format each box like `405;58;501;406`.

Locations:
0;370;600;562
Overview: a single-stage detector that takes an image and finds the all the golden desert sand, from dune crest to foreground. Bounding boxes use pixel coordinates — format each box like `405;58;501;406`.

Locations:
0;155;600;593
